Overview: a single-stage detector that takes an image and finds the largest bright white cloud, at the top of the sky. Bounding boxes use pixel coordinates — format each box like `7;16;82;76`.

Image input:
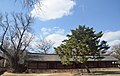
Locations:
31;0;76;21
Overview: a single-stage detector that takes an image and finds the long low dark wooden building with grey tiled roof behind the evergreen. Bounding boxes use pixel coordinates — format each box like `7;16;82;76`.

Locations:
26;53;118;69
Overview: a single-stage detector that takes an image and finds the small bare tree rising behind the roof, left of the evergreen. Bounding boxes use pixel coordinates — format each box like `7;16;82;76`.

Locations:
36;39;54;54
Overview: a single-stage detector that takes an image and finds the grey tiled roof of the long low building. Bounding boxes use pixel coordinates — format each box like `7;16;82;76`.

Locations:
26;53;118;61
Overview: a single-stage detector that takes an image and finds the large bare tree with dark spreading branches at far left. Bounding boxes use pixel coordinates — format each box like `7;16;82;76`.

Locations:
0;14;33;72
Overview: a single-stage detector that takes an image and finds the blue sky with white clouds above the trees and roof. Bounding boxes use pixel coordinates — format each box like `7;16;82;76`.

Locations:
0;0;120;50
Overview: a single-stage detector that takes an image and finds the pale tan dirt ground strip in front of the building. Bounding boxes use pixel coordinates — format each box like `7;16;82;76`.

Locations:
2;68;120;76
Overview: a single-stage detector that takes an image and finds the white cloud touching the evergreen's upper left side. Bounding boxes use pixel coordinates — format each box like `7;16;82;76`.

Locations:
46;34;66;47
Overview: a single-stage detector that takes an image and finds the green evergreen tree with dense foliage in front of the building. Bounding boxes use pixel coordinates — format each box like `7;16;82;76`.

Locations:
55;26;109;73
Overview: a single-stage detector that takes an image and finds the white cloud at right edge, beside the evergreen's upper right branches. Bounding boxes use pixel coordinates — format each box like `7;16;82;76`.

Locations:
101;31;120;46
